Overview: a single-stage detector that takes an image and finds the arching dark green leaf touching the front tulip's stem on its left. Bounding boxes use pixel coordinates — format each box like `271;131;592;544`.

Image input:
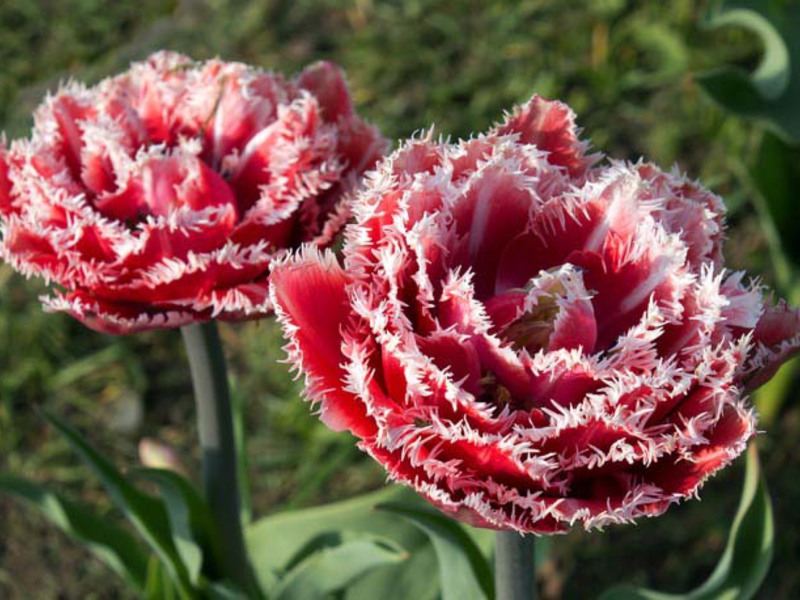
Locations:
378;503;494;600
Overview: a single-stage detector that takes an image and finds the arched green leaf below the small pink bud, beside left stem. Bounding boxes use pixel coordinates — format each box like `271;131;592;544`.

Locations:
133;469;222;586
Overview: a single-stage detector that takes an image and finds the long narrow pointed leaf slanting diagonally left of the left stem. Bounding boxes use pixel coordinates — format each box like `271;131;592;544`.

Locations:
45;413;192;596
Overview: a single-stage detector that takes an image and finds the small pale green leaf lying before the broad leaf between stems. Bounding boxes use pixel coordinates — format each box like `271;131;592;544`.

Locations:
269;532;407;600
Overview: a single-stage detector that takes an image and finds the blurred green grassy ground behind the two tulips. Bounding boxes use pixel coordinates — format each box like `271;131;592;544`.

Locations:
0;0;800;599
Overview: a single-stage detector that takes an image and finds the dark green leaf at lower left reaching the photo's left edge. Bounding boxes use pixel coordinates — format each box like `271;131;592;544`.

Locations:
0;473;147;591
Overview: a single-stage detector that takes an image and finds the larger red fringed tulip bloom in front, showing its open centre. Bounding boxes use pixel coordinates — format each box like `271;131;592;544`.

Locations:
271;97;800;533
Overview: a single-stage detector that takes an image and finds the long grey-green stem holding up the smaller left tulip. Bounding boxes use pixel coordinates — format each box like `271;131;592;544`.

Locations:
181;321;260;595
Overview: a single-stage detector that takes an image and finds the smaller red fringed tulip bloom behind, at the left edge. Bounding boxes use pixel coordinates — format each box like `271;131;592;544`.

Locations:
0;52;385;333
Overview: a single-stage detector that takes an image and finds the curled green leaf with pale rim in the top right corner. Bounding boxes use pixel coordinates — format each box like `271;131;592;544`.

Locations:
697;0;800;145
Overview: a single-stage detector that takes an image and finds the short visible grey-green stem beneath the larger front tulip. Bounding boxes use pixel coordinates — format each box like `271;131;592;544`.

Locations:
494;531;536;600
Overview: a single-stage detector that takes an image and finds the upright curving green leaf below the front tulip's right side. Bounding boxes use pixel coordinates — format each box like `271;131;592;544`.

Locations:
600;445;775;600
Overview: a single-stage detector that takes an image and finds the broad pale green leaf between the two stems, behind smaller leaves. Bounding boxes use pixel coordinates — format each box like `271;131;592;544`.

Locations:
245;486;439;600
